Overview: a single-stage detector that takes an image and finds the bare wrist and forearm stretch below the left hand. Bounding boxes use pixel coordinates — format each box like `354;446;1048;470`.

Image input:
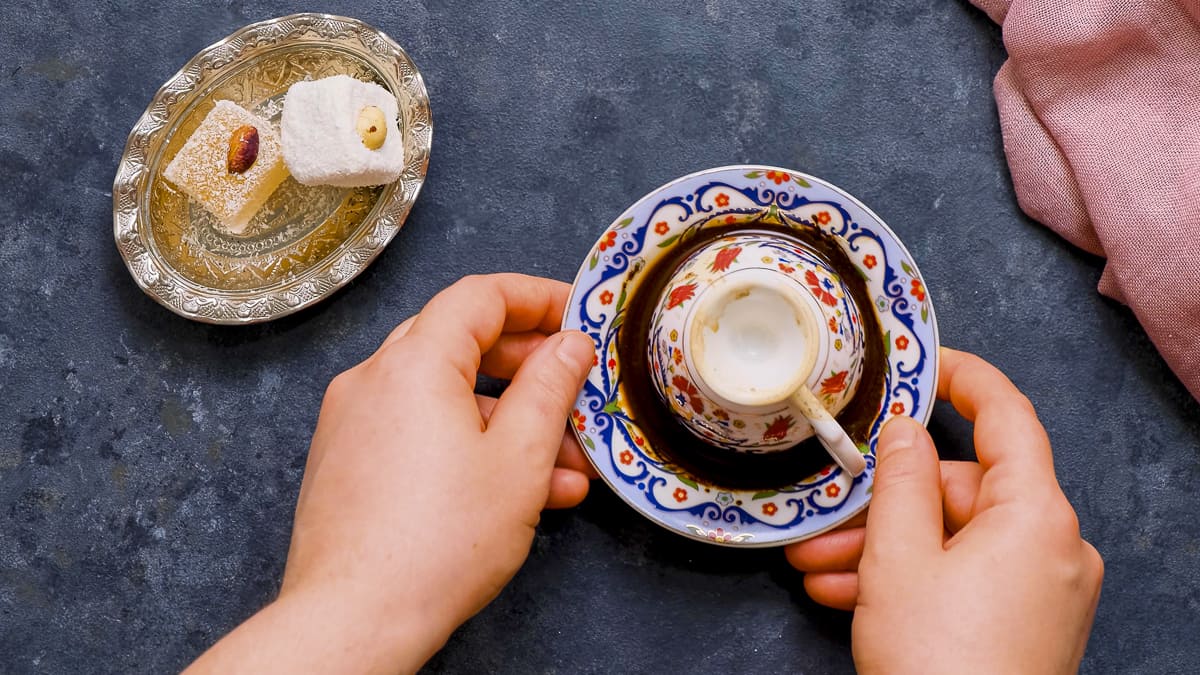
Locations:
186;581;449;675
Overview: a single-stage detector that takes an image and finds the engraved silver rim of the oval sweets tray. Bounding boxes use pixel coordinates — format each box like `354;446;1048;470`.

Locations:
113;12;433;325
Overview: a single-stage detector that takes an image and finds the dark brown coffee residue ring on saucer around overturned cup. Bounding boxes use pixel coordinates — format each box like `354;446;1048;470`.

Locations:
617;221;887;490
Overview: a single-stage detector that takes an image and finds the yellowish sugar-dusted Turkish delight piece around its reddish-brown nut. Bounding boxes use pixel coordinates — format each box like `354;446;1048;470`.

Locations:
163;101;288;234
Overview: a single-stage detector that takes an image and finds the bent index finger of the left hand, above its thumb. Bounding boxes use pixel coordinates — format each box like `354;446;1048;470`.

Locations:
408;274;570;383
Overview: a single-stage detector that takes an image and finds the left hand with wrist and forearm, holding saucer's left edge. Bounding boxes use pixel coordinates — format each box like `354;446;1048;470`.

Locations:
194;270;594;673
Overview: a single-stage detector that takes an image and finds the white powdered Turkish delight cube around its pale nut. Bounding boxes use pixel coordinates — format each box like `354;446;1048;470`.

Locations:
280;74;404;187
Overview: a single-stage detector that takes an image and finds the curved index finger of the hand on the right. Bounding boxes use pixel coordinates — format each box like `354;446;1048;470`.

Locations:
937;350;1060;502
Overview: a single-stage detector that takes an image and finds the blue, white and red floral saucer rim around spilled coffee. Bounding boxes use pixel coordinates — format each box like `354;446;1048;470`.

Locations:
563;166;938;548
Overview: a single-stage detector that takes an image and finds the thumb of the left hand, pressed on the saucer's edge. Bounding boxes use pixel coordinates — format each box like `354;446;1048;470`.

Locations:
487;330;595;472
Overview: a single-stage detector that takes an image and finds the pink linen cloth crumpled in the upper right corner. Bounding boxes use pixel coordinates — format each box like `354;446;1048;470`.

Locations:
972;0;1200;400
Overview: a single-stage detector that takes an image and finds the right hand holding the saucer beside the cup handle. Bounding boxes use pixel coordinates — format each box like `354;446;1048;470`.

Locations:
787;350;1104;674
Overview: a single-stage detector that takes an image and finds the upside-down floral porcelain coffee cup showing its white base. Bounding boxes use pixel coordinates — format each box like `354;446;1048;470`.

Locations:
648;232;870;456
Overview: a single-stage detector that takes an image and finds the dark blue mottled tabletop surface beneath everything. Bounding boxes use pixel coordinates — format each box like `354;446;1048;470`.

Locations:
0;0;1200;673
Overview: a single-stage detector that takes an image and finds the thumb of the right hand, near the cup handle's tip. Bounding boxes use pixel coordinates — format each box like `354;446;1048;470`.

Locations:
863;417;943;566
